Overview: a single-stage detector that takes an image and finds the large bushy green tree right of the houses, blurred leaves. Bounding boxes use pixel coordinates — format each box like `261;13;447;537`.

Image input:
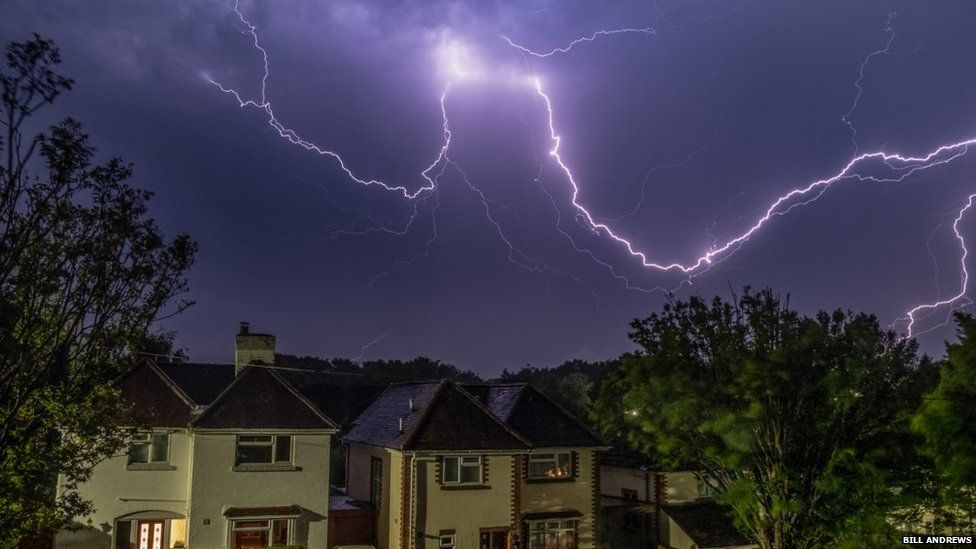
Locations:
595;288;933;548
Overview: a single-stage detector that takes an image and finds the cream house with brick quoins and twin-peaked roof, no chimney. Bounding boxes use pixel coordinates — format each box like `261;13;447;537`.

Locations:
343;381;604;549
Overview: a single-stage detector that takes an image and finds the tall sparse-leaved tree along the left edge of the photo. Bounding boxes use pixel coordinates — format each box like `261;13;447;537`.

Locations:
0;35;196;547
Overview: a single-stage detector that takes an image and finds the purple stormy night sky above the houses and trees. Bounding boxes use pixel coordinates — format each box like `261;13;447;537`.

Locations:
0;0;976;375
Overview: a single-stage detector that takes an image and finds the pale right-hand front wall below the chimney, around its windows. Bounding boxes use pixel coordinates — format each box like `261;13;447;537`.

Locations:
188;431;331;549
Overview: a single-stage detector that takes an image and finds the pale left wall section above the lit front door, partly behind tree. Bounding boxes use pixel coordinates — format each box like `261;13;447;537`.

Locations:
55;429;192;549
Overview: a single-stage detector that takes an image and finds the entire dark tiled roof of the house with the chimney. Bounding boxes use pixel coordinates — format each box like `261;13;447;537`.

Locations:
116;359;338;430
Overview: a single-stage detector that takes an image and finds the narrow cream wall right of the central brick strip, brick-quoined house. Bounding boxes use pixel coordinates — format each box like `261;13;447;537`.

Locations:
522;449;600;549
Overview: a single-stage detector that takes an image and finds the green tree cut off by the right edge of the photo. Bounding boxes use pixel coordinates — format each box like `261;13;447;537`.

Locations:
911;313;976;532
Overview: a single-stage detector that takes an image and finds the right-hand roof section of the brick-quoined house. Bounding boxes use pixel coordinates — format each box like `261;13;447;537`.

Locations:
465;383;603;448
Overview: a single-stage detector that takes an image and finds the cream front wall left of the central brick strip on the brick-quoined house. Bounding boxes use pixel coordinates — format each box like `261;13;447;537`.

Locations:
415;455;513;549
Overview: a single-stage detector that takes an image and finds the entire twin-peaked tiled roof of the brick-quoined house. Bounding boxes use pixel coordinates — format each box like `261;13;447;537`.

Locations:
343;380;602;451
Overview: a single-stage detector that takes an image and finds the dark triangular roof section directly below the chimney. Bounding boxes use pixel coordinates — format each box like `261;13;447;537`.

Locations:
191;367;338;430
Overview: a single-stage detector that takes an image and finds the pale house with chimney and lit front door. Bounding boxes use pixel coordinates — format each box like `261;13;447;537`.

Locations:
55;325;337;549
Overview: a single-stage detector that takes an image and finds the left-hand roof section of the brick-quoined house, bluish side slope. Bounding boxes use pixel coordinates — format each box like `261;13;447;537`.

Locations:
343;381;530;450
